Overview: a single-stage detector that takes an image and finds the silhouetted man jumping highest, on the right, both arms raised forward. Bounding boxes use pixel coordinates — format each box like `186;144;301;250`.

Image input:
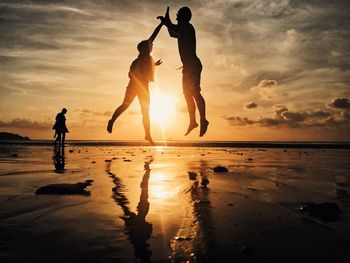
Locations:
157;7;209;136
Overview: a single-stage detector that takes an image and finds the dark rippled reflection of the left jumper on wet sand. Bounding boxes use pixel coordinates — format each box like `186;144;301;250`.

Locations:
106;160;153;262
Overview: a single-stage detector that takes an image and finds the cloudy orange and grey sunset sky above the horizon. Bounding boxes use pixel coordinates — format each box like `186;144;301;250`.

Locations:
0;0;350;141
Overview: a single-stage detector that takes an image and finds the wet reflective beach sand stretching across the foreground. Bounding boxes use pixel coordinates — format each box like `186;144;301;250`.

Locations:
0;145;350;262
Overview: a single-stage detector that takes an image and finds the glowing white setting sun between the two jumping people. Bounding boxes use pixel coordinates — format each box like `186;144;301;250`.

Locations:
150;90;175;127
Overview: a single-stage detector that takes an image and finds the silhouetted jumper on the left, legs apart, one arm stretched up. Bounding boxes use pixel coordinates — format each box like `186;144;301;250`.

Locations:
107;23;163;144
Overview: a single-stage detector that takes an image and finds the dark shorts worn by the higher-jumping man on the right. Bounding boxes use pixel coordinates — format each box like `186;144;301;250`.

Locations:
182;59;202;93
